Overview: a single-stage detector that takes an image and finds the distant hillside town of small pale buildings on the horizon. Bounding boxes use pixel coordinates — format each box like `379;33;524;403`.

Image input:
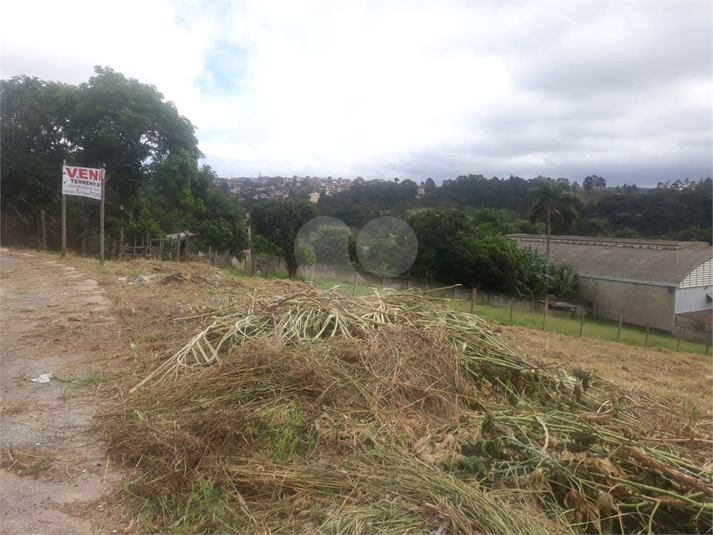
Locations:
215;175;425;203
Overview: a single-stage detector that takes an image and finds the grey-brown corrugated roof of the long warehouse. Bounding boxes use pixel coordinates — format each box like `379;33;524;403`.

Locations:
507;234;713;286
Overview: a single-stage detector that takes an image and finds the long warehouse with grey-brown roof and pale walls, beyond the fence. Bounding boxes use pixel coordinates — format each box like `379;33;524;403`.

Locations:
507;234;713;341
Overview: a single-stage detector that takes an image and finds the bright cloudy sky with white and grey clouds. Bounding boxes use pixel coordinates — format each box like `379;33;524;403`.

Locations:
0;0;713;185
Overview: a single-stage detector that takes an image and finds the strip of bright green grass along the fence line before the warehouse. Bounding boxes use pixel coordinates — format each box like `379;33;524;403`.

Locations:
228;268;710;354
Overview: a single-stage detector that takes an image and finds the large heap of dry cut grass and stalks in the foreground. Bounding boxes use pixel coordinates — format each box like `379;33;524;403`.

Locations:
87;258;713;535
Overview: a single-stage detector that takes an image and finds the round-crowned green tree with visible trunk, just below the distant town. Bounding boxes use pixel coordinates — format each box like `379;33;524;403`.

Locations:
250;199;319;278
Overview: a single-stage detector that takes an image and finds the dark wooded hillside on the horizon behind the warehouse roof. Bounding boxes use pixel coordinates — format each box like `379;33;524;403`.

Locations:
318;175;713;243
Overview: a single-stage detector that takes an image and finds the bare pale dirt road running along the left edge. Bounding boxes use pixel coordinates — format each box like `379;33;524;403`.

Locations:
0;249;132;535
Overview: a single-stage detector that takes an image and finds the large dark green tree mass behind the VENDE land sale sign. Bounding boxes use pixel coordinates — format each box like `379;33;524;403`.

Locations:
0;67;247;256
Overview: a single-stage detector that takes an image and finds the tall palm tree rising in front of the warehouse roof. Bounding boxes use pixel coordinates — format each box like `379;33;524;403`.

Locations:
528;177;579;274
